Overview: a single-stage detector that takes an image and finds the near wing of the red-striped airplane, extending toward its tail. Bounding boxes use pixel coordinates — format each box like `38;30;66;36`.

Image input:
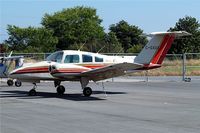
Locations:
79;63;143;81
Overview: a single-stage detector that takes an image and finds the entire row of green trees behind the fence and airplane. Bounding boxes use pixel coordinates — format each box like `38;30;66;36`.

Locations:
1;6;200;54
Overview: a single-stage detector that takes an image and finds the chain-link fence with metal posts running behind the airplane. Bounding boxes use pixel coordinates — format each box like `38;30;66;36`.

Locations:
0;53;200;82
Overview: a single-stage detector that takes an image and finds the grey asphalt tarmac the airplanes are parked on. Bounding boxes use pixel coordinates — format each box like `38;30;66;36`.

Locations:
0;81;200;133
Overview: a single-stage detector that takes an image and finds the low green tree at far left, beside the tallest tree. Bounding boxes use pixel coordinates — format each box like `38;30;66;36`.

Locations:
5;25;58;52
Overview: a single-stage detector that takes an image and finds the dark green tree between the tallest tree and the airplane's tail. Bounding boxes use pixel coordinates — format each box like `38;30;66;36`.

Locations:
109;20;147;53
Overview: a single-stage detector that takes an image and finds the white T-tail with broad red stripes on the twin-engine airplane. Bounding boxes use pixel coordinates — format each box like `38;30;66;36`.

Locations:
134;31;191;69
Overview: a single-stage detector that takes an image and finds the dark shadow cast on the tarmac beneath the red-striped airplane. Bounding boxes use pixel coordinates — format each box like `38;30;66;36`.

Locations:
0;90;126;101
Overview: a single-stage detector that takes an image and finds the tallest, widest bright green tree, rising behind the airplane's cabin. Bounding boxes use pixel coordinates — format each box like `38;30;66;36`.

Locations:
42;6;105;49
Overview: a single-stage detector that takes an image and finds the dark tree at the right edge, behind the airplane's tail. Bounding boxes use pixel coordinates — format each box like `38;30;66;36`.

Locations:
169;16;200;54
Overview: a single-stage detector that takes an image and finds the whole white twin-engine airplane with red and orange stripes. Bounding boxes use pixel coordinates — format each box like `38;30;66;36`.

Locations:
10;31;190;96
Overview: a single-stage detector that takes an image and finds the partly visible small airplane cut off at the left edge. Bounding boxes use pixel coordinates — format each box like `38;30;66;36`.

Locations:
0;52;23;87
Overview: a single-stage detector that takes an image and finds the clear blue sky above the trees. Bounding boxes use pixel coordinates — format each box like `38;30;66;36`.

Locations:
0;0;200;42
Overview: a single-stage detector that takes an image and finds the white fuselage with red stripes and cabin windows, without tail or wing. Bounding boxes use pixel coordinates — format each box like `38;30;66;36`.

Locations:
9;50;135;83
